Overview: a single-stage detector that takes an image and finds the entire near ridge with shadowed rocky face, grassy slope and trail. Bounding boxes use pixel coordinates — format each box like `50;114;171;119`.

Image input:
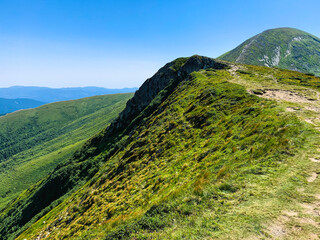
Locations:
0;56;320;240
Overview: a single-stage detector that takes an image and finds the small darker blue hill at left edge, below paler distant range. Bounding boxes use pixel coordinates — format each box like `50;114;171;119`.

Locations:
0;98;45;116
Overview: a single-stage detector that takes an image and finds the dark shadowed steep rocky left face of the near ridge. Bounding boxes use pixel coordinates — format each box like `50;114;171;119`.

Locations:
0;56;227;238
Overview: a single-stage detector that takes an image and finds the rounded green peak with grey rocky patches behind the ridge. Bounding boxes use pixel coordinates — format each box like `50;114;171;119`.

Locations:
219;28;320;75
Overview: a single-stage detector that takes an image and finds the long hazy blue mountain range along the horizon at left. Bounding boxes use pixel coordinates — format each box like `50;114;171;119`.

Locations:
0;86;137;103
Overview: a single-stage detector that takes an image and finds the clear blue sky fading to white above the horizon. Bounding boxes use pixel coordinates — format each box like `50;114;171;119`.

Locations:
0;0;320;88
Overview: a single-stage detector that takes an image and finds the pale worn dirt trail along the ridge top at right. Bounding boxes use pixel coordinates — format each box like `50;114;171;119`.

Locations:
229;65;320;240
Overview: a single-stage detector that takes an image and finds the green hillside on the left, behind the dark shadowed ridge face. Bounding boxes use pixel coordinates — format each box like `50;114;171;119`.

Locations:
0;93;133;209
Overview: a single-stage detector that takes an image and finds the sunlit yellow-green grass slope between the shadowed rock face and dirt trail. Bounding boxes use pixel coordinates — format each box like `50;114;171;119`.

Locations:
17;68;317;239
